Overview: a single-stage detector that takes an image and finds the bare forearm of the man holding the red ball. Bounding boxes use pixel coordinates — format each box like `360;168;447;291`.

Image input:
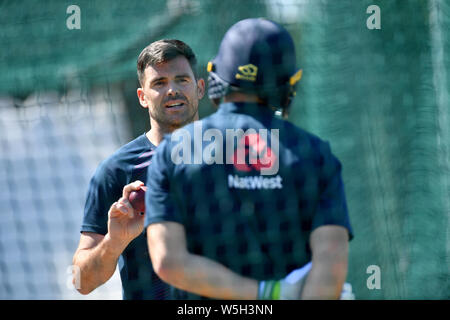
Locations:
73;234;127;294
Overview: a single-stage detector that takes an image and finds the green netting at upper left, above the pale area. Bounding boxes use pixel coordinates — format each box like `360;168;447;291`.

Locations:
0;0;265;95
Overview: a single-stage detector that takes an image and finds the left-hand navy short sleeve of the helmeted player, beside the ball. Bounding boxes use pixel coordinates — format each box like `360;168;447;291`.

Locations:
145;140;181;228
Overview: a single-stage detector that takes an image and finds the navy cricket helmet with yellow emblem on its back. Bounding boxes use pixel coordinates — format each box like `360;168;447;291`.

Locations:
207;18;302;108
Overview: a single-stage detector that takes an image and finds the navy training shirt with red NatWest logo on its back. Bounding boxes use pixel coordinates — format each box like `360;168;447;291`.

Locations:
145;103;353;299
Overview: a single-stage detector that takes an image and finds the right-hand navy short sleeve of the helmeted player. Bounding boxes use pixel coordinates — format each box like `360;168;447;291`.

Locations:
312;143;353;239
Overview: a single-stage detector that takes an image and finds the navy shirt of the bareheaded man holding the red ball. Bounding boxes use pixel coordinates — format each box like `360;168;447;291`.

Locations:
81;134;170;300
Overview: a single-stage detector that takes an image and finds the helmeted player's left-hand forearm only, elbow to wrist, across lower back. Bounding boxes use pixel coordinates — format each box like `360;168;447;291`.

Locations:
162;254;258;300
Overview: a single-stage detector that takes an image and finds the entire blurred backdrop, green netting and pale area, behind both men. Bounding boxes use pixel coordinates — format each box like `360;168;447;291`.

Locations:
0;0;450;299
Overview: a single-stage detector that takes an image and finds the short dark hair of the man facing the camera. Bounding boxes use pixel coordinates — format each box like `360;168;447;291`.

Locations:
137;39;197;85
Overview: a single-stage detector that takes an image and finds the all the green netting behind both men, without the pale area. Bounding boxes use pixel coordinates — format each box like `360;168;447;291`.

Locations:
0;0;450;299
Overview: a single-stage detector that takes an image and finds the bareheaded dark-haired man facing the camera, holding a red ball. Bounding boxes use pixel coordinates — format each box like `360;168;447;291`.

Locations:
73;40;205;299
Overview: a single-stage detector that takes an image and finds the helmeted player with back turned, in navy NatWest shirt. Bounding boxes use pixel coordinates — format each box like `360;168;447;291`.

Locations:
145;19;353;299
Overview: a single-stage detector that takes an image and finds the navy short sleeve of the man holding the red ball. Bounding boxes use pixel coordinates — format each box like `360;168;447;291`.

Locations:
81;163;122;235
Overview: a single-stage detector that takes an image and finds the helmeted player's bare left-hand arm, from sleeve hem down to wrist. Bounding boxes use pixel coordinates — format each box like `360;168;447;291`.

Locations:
147;222;258;300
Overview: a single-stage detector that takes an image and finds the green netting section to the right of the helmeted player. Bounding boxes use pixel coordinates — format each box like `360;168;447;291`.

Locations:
294;1;450;299
